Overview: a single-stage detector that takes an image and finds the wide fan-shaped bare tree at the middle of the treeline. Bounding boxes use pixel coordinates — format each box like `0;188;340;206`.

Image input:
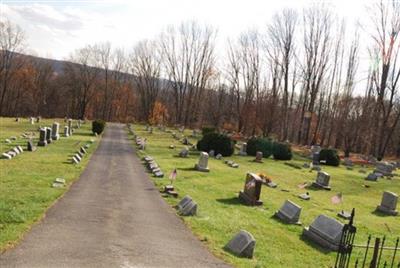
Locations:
160;22;216;126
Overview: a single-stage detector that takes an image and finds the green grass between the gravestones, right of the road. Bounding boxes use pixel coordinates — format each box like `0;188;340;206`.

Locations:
130;125;400;267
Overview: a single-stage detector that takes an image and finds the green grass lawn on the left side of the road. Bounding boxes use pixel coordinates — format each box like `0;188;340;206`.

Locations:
0;118;98;252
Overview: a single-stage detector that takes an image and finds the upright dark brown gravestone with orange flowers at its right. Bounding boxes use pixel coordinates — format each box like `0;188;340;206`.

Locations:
239;173;263;206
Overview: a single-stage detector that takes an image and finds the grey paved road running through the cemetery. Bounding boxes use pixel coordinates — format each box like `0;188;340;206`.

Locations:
0;124;230;268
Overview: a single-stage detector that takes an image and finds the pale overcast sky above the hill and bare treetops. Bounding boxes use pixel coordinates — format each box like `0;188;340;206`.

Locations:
0;0;376;59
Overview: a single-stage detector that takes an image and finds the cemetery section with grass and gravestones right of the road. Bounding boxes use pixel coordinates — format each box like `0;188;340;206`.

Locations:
130;124;400;267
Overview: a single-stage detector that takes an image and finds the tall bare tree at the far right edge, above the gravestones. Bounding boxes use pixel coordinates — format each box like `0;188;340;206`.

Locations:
371;0;400;159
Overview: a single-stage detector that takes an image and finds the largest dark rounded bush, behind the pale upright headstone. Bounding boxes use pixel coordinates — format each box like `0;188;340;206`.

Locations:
197;132;234;156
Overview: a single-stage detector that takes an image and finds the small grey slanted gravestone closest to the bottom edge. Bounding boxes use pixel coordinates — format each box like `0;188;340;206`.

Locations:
225;230;256;259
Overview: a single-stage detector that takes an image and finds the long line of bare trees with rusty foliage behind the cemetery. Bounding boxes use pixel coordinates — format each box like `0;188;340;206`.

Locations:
0;1;400;158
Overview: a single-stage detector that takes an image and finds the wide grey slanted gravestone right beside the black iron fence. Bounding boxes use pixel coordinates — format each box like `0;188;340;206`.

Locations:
303;215;343;251
